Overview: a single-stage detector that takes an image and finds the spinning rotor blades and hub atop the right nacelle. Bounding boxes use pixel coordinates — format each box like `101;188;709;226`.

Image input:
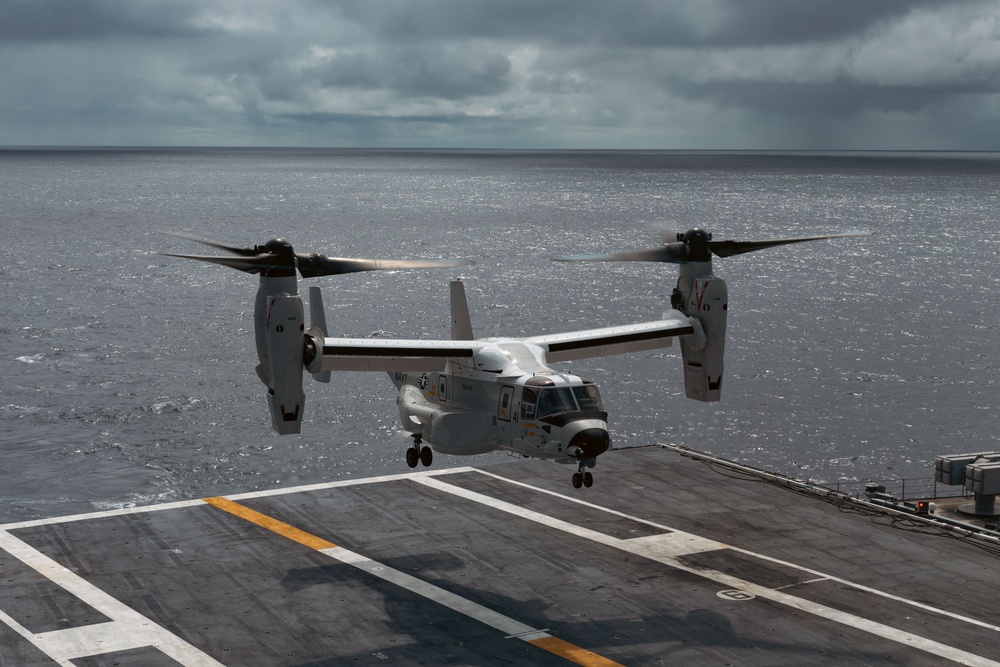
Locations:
553;227;872;264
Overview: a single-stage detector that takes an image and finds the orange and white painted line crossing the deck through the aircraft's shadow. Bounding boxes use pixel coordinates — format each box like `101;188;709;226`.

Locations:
205;497;624;667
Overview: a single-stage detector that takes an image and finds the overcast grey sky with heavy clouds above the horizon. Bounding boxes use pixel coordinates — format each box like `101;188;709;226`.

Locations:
0;0;1000;150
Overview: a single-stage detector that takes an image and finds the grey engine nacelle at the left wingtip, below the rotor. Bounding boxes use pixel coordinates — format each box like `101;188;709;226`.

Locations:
257;294;306;435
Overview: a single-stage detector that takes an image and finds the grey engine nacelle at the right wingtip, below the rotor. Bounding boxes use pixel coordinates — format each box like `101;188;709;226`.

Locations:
674;264;729;402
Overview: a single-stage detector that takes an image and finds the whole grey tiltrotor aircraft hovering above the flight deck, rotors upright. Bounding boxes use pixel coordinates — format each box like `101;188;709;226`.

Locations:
167;229;868;488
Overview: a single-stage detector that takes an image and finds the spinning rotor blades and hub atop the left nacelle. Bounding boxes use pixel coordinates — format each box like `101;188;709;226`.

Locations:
161;234;475;278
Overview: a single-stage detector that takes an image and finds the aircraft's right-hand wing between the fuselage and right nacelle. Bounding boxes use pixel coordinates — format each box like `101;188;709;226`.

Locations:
523;310;694;362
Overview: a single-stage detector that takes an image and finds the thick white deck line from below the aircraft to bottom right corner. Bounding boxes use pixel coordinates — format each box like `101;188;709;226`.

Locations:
414;473;1000;667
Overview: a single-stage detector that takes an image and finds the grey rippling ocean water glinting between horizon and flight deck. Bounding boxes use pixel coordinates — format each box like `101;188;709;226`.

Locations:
0;149;1000;522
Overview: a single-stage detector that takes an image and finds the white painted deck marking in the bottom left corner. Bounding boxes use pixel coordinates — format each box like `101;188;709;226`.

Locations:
0;530;224;667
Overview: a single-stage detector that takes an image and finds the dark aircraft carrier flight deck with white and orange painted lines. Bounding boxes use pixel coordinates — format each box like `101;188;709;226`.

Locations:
0;446;1000;667
